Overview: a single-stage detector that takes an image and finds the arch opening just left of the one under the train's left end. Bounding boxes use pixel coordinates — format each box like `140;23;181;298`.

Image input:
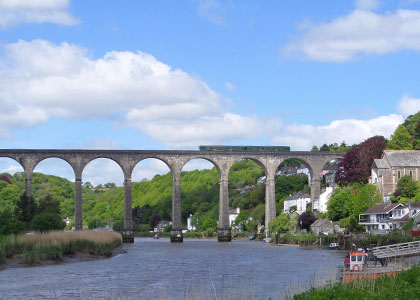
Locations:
131;158;172;232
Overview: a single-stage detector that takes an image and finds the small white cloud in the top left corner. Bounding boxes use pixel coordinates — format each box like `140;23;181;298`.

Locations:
0;0;78;29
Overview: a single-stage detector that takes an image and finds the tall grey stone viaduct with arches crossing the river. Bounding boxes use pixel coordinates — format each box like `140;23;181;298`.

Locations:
0;149;344;242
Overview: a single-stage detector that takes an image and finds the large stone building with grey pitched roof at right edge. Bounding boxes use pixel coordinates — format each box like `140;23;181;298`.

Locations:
369;150;420;200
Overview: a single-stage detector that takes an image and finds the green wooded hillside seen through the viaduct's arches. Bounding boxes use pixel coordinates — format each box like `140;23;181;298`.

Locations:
0;161;308;230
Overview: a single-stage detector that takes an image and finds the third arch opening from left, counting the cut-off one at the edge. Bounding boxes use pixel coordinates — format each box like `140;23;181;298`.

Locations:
82;158;124;231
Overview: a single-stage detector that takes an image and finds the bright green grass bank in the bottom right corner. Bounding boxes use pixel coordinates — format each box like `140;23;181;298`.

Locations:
289;266;420;300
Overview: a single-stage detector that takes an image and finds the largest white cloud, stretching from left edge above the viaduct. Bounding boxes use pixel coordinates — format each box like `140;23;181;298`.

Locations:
0;40;279;147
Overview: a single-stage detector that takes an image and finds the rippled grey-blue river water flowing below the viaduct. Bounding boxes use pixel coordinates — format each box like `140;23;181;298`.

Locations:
0;238;344;300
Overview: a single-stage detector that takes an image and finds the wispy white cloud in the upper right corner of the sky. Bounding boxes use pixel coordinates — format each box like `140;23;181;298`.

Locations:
284;4;420;62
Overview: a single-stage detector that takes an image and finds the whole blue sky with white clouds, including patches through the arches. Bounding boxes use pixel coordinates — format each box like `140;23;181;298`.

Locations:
0;0;420;184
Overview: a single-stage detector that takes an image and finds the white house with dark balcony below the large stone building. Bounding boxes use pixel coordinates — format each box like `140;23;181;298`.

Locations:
359;202;404;233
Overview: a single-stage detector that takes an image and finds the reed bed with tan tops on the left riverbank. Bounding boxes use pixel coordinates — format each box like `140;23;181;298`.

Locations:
0;230;121;269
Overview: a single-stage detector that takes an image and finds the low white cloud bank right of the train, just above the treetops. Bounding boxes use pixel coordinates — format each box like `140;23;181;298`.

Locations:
273;114;404;150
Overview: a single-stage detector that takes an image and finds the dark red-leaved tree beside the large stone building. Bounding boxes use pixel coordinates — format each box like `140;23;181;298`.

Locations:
335;136;387;186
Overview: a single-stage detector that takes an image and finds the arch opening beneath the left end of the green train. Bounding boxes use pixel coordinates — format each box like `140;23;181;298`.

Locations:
181;158;220;232
